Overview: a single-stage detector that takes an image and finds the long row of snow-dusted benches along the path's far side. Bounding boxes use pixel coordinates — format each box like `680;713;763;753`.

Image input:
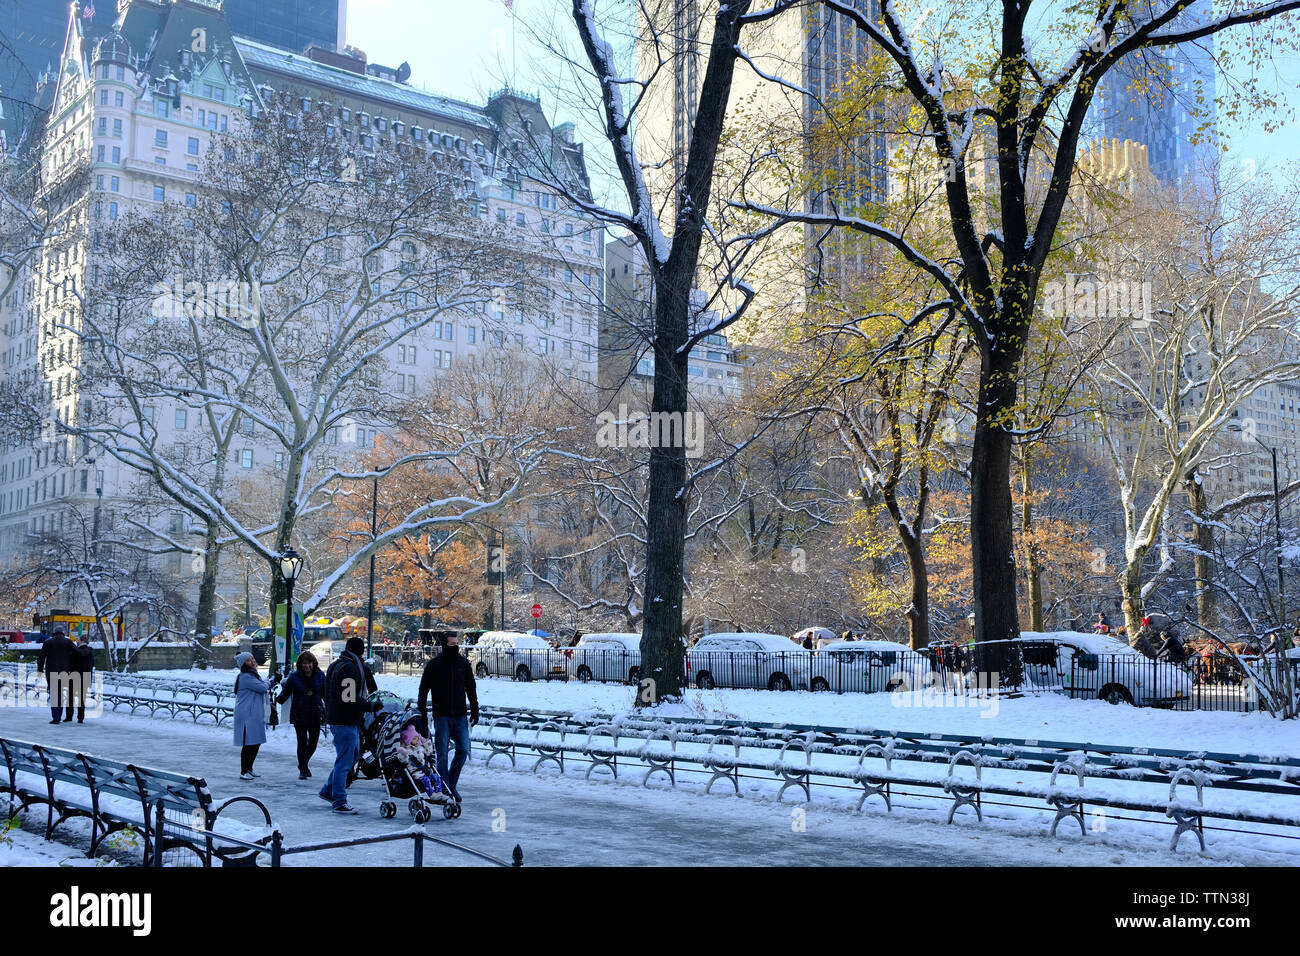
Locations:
10;660;1300;847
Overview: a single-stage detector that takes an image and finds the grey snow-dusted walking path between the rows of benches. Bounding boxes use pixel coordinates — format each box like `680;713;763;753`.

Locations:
0;709;1268;866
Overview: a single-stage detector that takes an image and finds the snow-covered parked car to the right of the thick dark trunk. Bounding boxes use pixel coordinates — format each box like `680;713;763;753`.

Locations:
1019;631;1192;706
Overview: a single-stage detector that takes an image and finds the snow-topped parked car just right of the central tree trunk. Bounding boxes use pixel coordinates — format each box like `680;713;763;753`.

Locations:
686;632;813;691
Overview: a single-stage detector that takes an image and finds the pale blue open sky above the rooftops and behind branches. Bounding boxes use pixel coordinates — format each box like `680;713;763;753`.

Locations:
347;0;1300;187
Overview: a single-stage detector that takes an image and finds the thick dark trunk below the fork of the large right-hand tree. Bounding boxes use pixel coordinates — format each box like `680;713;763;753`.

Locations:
971;356;1021;687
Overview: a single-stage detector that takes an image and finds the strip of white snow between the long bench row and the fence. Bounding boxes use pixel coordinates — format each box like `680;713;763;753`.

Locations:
137;670;1300;757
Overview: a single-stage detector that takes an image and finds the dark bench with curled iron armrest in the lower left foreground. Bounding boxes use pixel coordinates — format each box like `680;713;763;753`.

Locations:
0;737;272;866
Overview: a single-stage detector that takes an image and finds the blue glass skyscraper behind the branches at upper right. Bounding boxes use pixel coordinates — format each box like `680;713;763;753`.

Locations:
1089;0;1217;186
